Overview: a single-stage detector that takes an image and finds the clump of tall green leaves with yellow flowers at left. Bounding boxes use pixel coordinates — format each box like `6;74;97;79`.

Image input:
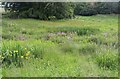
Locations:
0;45;31;67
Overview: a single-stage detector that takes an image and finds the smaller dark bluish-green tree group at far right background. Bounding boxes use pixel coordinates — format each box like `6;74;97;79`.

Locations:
74;2;119;16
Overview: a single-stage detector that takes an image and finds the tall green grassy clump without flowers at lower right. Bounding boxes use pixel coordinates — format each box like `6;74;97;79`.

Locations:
95;51;118;69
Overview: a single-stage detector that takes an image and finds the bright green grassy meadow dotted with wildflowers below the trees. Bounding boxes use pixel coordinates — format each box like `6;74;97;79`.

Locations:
0;15;118;77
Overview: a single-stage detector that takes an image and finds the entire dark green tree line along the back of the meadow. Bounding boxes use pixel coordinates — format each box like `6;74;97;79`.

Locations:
3;2;119;20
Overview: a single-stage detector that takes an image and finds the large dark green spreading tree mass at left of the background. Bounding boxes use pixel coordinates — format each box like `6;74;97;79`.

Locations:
5;2;74;20
